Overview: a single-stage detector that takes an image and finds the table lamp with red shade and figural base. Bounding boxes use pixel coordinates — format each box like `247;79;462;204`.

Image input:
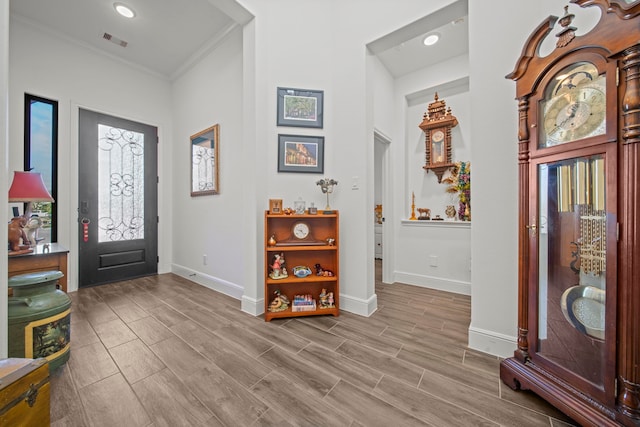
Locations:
9;171;53;252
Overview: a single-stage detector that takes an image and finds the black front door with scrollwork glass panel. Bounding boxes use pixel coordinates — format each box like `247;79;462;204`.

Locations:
78;109;158;287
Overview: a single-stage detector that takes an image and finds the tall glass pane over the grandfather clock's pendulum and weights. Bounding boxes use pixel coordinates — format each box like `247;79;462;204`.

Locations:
538;155;607;385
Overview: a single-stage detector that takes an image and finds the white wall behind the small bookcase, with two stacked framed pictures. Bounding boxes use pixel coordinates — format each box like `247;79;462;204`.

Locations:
231;0;451;314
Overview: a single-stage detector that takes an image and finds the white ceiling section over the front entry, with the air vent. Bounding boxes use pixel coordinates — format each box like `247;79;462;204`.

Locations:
10;0;236;78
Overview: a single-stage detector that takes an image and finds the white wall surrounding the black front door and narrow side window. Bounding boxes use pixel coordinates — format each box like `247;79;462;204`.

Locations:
8;16;173;291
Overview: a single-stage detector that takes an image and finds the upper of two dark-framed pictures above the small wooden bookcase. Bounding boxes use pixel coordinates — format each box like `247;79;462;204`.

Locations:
277;87;324;128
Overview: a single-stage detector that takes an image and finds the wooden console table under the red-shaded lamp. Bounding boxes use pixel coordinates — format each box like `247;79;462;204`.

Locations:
8;243;69;292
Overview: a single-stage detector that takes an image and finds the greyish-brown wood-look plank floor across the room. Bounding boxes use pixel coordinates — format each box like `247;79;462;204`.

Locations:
51;265;573;427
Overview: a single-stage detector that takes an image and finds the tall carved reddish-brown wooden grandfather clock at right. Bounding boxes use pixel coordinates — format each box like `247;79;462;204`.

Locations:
500;0;640;426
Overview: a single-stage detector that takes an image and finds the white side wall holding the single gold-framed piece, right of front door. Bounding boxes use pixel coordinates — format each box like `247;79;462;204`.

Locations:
172;27;248;298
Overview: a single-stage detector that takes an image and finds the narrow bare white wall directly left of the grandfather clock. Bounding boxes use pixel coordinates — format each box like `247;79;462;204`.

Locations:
469;0;577;357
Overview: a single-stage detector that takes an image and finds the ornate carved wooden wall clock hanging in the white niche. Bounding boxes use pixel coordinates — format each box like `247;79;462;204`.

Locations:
419;93;458;183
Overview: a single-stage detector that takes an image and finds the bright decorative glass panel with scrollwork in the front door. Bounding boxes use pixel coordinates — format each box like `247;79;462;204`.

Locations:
98;124;144;243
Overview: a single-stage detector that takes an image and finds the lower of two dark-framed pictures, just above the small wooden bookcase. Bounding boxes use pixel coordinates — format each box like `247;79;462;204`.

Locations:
278;135;324;173
